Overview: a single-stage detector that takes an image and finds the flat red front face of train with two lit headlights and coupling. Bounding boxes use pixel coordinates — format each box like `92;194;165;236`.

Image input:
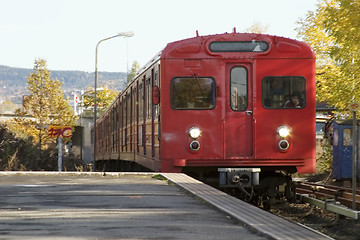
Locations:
160;33;315;204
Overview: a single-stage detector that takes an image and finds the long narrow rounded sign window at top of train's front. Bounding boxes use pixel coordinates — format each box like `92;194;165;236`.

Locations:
209;41;269;52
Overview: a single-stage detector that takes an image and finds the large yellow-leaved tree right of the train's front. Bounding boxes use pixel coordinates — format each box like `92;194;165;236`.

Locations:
297;0;360;112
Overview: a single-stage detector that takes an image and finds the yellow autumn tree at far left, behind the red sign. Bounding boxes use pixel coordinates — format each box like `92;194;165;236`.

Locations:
11;59;76;148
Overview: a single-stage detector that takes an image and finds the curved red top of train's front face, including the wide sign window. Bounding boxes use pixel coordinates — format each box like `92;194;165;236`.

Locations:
160;29;315;59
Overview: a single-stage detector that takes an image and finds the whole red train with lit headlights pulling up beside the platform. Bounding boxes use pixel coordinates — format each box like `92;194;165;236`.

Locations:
96;29;315;206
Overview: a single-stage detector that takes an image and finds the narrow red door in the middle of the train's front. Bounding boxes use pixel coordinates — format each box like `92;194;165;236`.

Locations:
224;64;253;157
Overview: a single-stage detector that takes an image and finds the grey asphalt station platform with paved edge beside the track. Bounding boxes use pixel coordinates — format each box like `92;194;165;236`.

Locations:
0;172;330;239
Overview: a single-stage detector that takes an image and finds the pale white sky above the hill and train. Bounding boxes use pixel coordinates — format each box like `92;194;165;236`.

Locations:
0;0;317;72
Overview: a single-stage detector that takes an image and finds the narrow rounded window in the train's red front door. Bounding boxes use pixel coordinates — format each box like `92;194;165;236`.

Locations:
230;67;248;111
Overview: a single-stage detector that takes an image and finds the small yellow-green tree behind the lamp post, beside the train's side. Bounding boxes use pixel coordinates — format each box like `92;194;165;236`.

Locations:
82;87;118;116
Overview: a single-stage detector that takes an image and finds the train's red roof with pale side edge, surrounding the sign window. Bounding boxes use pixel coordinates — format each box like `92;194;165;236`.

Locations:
136;29;315;80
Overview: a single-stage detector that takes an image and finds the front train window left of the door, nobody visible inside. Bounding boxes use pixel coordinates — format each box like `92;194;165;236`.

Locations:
171;75;215;109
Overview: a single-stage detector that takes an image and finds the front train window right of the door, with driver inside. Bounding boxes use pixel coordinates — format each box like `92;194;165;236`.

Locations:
262;76;306;109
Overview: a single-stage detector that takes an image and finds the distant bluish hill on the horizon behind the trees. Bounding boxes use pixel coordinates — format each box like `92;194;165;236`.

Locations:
0;65;126;107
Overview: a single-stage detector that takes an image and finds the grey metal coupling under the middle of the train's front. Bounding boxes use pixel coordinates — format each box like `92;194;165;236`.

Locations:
218;168;261;188
